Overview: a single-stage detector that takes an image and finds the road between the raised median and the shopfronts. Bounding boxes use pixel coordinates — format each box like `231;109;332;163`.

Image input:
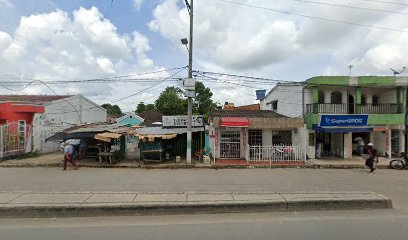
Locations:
0;168;408;209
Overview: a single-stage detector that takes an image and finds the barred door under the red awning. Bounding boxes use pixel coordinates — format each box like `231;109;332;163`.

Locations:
220;130;241;159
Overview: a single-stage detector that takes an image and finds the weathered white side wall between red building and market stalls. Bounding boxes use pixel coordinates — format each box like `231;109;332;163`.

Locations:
33;95;107;153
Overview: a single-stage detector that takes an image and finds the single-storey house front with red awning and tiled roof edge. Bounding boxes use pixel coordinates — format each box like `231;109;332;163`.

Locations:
209;110;303;160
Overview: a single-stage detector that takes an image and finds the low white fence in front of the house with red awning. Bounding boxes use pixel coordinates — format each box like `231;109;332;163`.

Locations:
247;145;306;163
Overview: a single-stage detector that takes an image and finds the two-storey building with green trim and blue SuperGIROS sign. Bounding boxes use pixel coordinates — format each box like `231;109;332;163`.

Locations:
302;76;408;159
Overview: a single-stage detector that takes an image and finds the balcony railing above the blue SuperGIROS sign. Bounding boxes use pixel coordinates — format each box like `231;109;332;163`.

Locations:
305;103;402;114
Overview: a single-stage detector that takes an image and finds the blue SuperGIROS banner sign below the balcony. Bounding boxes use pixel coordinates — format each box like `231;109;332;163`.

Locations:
319;115;368;127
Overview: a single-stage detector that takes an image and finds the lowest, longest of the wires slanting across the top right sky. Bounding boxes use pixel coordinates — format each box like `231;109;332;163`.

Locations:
219;0;408;33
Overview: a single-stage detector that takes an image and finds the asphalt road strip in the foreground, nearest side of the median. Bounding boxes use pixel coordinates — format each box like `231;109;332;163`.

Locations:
0;210;408;240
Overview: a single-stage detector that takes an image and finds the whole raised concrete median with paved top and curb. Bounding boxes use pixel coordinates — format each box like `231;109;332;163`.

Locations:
0;192;392;218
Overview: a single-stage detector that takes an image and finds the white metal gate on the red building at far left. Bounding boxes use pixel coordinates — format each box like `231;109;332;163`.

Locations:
0;121;31;159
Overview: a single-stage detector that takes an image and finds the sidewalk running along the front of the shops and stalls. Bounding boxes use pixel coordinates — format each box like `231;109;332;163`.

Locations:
0;152;391;169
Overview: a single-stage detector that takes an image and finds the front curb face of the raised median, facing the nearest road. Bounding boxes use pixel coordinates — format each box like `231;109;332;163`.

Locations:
0;196;392;218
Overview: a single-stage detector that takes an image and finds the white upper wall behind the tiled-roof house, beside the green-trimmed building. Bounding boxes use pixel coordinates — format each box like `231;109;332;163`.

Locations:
261;85;303;117
